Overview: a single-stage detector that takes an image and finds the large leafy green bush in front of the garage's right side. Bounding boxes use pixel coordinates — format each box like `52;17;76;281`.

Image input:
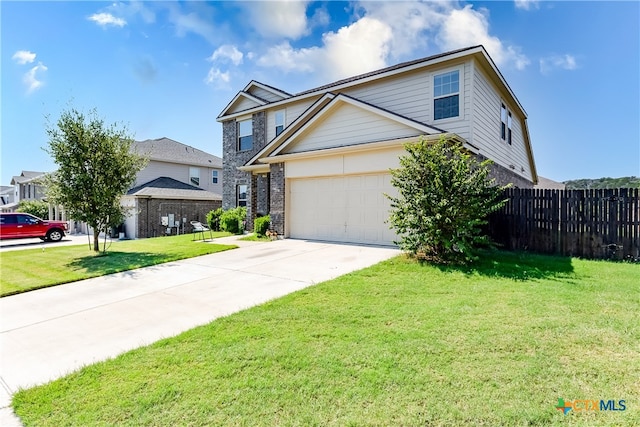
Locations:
387;138;507;263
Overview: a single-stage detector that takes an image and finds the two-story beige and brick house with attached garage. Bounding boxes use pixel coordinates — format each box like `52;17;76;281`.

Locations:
217;46;538;244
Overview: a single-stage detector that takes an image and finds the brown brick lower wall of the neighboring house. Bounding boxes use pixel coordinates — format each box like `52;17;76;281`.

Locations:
134;198;222;238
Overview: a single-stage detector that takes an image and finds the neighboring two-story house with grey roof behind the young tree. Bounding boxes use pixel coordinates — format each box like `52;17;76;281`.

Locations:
122;138;222;238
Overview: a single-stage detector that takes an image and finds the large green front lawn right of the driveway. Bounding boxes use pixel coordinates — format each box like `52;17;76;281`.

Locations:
12;252;640;426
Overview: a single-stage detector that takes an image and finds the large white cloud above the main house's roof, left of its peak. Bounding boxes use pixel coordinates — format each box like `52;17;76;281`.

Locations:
258;17;391;80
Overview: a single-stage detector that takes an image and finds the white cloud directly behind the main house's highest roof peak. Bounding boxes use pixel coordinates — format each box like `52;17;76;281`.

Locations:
437;5;530;70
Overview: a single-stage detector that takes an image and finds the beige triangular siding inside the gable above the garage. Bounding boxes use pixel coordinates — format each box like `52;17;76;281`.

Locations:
286;103;420;153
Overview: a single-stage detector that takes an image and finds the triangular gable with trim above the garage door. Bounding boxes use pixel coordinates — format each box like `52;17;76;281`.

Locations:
271;94;445;156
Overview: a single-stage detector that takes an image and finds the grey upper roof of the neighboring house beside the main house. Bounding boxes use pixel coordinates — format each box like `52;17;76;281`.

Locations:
131;138;222;169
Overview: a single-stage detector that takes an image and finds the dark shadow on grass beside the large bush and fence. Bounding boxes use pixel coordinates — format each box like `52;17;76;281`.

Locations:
430;250;574;281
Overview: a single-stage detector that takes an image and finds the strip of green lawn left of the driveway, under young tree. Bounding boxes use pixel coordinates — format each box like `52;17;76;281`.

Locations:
0;233;236;296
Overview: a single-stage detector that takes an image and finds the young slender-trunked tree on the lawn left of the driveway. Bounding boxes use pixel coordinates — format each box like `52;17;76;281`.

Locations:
45;109;146;252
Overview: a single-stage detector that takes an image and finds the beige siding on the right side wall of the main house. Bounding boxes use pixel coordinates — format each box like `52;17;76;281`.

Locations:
470;63;532;180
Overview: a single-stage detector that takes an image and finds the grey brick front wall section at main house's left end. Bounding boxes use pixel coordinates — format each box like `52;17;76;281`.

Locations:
222;111;267;230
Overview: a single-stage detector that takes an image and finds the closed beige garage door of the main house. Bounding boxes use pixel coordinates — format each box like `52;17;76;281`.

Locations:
287;174;397;245
